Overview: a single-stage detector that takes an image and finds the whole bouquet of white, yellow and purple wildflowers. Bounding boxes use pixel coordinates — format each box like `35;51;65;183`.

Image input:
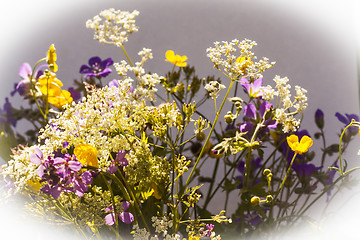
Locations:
0;9;360;239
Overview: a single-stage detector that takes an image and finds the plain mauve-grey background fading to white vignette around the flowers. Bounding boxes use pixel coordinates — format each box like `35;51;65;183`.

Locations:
0;0;360;239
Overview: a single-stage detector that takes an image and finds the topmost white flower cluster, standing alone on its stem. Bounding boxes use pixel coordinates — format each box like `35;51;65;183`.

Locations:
86;8;139;47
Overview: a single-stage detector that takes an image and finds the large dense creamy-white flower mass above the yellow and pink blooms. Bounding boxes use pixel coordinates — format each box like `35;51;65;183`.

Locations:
39;84;138;168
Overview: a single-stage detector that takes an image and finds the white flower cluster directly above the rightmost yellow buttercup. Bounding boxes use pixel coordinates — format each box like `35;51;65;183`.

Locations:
261;76;308;133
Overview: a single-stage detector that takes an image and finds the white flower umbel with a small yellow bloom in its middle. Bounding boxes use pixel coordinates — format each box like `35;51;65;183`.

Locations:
206;39;275;80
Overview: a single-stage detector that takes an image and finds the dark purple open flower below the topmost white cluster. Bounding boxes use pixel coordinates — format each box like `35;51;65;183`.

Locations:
80;56;114;78
